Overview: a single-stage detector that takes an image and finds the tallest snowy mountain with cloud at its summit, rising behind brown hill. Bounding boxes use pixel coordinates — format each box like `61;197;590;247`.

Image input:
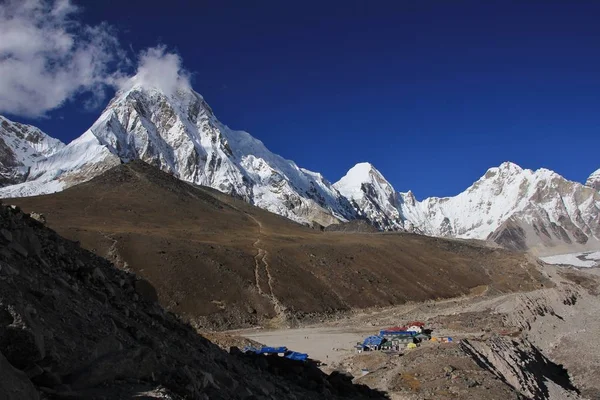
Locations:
0;86;356;225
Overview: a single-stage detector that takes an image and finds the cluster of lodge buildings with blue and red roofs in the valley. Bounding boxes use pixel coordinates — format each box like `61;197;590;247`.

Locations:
355;321;452;353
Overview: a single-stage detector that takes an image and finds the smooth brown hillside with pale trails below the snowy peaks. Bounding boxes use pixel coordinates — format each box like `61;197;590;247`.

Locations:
8;161;544;328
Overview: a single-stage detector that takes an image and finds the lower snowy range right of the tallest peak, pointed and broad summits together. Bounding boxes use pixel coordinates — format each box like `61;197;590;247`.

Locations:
334;162;600;253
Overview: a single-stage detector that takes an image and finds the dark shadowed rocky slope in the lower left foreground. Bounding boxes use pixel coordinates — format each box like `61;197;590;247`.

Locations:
0;206;385;399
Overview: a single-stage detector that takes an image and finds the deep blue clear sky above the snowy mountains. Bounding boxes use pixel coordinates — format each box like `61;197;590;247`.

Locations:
4;0;600;198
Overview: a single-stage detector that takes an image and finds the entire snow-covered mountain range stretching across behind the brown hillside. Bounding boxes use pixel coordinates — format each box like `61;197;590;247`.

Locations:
0;84;600;255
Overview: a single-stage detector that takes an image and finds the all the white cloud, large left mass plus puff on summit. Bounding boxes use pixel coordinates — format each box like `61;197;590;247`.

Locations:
0;0;190;117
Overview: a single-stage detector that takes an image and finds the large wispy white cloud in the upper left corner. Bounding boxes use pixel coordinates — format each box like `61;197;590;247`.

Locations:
0;0;125;117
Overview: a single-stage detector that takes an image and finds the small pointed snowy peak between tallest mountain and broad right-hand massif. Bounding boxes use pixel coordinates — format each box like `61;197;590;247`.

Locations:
333;163;404;230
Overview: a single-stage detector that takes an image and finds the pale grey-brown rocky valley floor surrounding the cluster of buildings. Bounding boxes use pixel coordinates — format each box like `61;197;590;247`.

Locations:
229;265;600;400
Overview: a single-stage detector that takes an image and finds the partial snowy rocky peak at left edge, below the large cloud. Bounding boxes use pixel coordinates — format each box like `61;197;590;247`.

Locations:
0;116;65;186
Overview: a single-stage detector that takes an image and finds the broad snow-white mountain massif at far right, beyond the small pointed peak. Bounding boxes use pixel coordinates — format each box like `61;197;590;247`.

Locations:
402;163;600;252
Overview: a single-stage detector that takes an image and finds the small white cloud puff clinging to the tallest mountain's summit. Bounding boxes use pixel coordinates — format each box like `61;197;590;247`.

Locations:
119;45;191;96
